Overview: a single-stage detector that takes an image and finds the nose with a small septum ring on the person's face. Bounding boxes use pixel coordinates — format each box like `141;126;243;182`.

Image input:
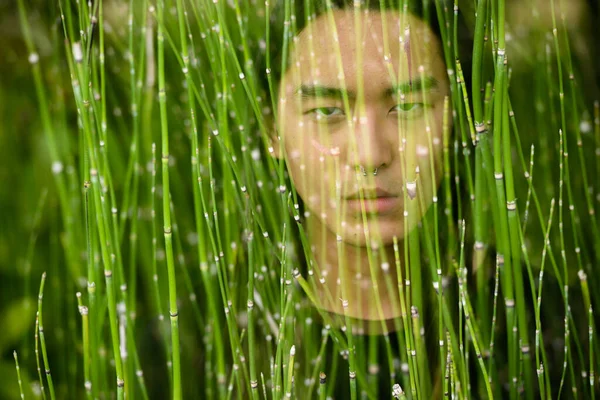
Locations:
348;106;397;174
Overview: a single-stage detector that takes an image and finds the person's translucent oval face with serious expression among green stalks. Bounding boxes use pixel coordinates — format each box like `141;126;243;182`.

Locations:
273;10;449;246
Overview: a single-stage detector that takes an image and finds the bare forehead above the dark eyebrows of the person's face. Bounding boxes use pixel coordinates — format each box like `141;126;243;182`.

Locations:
286;9;444;86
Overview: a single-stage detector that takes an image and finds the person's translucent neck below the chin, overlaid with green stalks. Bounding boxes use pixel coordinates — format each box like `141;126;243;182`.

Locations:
307;216;403;333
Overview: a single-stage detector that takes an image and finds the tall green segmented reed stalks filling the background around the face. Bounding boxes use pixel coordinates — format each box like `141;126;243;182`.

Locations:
0;0;600;399
